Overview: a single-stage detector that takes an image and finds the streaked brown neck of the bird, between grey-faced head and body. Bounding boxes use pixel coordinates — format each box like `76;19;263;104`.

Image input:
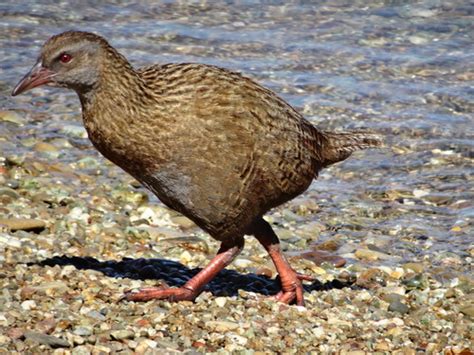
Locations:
78;47;159;175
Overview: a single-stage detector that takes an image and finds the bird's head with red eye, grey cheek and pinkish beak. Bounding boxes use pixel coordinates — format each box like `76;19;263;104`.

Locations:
12;31;109;96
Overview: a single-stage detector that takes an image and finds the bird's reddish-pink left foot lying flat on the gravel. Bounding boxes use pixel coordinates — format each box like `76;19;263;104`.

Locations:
122;287;198;302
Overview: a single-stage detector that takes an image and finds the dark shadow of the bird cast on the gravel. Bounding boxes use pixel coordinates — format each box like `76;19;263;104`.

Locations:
28;255;352;296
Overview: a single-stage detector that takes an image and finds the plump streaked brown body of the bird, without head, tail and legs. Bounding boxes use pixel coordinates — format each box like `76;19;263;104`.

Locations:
85;63;380;239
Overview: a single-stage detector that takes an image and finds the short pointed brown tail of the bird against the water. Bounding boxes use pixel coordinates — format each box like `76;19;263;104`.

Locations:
321;131;382;166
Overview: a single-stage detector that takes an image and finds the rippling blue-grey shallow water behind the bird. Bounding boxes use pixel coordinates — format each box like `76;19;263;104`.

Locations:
0;1;474;272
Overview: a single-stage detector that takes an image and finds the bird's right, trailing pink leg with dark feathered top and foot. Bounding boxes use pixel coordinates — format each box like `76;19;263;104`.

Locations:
251;218;313;306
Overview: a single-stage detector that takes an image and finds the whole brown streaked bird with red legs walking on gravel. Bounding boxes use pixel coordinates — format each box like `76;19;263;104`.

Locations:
12;31;380;305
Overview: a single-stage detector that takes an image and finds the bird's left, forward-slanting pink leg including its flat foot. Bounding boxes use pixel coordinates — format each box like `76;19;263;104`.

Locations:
124;237;244;302
